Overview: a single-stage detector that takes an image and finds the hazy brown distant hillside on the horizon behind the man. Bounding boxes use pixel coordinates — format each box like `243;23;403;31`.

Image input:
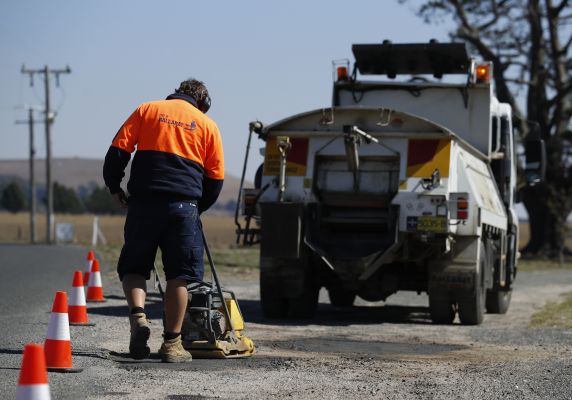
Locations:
0;158;245;205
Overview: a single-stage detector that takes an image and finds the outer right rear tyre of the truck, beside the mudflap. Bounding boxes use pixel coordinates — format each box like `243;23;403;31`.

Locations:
458;243;484;325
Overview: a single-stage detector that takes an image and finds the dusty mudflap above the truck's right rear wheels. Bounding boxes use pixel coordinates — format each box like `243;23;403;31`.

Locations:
428;236;481;296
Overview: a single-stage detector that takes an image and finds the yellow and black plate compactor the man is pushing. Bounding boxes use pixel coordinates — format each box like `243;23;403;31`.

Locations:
155;233;254;358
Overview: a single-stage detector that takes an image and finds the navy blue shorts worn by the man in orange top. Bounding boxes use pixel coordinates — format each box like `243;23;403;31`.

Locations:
117;199;204;282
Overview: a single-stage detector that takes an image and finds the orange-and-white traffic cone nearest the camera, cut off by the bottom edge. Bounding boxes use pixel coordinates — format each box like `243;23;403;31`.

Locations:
16;343;50;400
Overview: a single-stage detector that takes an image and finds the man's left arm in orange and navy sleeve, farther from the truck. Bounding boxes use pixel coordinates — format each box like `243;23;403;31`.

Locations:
103;107;142;195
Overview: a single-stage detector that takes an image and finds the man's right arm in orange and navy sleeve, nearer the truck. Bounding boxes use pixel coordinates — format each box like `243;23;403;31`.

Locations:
199;123;224;213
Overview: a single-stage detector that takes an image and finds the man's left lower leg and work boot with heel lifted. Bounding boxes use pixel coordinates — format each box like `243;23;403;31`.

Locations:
122;274;151;359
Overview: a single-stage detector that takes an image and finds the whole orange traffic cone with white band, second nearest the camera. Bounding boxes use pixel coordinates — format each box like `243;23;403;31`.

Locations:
44;292;81;372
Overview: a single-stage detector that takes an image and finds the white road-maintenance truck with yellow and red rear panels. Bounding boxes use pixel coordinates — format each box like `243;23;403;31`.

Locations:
236;42;544;324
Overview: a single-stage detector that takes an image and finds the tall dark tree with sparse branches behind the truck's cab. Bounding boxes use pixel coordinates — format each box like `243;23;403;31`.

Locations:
399;0;572;257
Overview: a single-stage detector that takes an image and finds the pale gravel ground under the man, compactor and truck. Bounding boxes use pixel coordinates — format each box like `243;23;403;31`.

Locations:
0;244;572;399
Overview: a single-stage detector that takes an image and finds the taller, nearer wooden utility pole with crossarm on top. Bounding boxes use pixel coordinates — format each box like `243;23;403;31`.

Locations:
21;65;71;244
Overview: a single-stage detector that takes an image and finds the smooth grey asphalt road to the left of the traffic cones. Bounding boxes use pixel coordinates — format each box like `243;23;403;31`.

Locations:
0;244;94;398
